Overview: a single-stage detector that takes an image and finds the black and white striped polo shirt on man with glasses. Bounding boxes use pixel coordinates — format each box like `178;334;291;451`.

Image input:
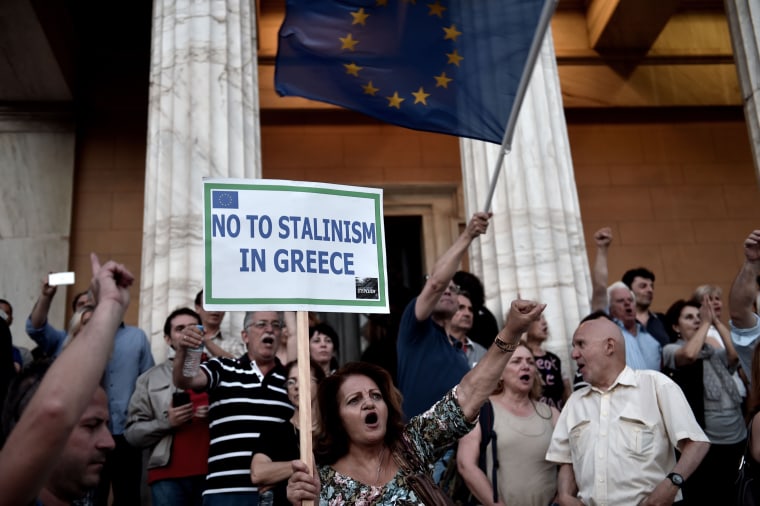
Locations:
201;355;293;495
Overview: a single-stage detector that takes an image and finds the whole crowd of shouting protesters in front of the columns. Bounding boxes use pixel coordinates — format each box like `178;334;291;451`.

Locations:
0;218;760;506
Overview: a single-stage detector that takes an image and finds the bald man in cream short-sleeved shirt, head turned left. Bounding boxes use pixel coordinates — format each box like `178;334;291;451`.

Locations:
546;318;710;506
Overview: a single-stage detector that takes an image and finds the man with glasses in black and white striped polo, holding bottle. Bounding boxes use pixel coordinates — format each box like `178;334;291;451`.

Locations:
173;311;293;506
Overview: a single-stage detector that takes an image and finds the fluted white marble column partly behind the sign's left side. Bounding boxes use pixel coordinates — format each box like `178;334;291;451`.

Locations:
140;0;261;362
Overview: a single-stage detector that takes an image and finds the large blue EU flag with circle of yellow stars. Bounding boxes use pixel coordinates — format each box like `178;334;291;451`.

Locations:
275;0;546;144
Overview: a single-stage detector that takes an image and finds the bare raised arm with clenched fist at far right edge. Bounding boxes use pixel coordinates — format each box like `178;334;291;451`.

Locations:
728;229;760;329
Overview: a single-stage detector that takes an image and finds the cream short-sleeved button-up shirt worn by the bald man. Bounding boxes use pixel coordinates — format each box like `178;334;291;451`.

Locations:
546;366;709;506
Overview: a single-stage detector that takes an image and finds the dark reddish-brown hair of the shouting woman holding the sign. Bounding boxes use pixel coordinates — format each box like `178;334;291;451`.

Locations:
314;362;404;465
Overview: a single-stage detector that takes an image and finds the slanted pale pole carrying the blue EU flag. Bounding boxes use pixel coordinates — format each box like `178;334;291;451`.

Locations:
485;0;559;212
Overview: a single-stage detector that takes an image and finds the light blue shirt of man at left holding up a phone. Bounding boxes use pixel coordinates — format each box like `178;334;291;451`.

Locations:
26;318;155;435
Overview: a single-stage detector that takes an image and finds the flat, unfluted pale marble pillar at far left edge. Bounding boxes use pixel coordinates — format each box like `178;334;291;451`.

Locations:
0;108;75;349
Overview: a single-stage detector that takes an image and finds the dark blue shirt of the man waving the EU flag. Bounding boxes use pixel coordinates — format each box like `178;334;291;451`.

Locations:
396;297;470;420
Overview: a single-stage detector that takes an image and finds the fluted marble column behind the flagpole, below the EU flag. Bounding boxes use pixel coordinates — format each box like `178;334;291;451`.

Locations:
461;32;591;371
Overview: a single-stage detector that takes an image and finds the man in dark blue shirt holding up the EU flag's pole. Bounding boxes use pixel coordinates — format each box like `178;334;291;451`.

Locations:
397;213;495;419
